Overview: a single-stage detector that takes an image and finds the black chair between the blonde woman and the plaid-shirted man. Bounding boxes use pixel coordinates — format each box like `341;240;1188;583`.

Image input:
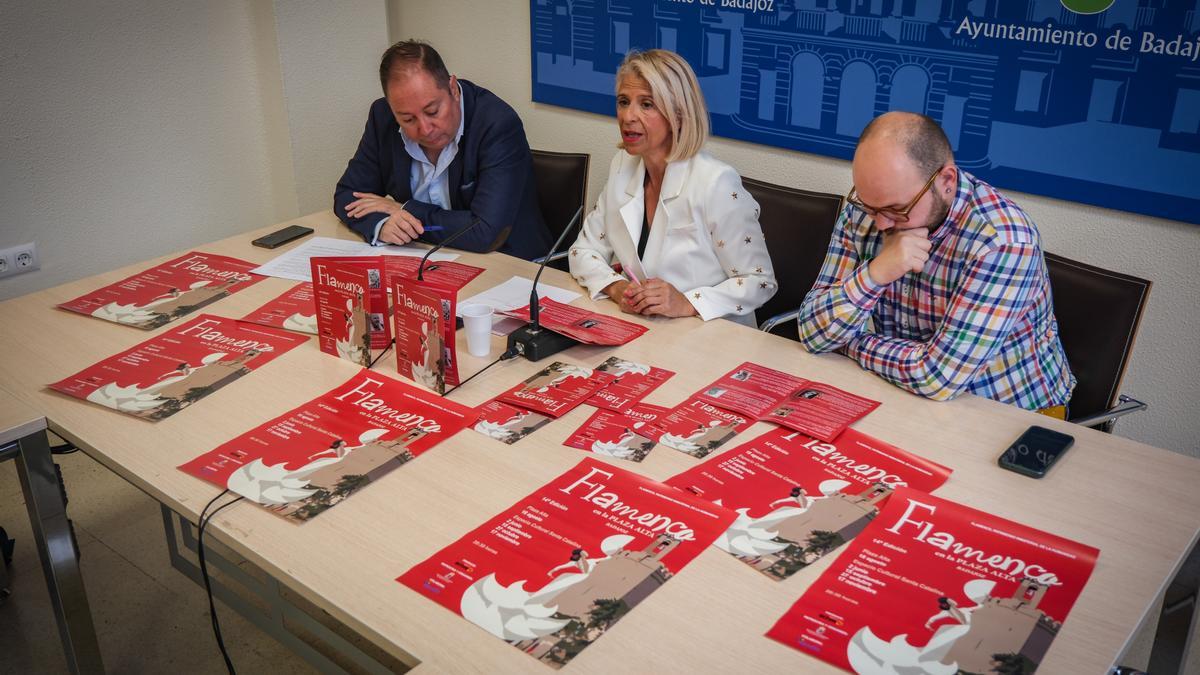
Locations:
742;178;841;340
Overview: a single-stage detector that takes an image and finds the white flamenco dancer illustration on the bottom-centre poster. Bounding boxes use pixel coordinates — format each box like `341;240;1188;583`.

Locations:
458;534;634;641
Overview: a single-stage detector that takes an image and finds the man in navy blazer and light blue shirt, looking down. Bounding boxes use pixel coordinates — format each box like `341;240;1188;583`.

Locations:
334;41;552;259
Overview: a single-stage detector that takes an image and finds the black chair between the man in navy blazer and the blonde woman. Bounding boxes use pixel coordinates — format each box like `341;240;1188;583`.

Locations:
532;150;592;271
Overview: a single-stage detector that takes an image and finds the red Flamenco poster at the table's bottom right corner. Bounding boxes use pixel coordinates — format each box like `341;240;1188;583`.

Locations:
767;488;1099;674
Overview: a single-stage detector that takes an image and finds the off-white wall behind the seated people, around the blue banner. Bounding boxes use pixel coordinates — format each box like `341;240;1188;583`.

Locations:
389;0;1200;456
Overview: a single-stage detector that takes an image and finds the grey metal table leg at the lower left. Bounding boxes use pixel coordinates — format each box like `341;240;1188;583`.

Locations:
17;430;104;673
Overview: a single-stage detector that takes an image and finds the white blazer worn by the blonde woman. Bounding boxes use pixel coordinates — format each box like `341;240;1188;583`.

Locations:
569;150;776;325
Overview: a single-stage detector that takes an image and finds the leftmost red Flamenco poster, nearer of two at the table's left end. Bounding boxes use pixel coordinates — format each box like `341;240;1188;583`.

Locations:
49;315;307;422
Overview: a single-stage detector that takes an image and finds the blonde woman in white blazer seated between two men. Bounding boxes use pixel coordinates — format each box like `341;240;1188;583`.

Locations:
569;49;775;325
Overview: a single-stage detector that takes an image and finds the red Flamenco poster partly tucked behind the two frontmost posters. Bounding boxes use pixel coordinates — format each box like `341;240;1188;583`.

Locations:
666;429;950;579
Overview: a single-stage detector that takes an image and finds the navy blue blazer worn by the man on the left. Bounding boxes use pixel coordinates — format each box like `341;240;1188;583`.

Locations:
334;79;553;259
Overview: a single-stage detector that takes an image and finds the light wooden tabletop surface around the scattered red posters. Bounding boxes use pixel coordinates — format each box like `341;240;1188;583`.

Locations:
0;211;1200;674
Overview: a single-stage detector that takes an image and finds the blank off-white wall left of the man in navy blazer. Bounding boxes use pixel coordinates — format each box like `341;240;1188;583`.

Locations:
0;0;388;294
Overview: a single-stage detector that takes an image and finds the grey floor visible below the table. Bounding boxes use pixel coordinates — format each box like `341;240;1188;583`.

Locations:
0;439;1200;675
